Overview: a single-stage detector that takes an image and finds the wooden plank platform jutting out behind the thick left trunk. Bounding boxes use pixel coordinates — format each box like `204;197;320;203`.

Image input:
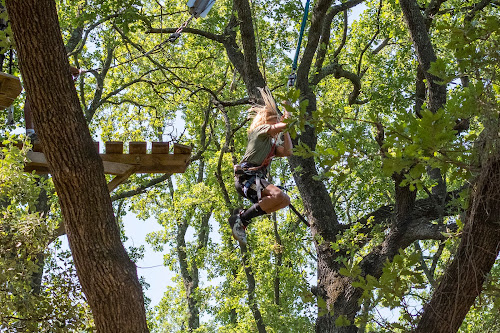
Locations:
2;141;192;192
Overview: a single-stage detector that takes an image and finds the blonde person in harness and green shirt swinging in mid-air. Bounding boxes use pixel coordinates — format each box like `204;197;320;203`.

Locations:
229;87;293;245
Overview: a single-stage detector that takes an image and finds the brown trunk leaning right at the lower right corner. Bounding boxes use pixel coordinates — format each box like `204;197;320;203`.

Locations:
415;158;500;333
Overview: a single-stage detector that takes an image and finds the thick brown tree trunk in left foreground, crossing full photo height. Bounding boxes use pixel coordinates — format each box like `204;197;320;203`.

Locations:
7;0;148;333
